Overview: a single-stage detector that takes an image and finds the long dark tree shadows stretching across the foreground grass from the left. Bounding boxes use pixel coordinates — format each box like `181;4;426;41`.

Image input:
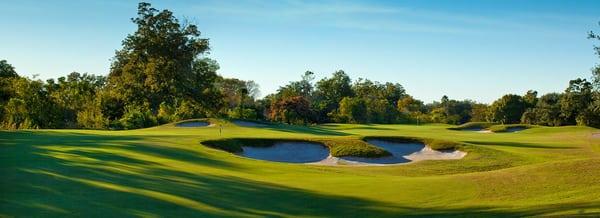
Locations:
0;133;600;217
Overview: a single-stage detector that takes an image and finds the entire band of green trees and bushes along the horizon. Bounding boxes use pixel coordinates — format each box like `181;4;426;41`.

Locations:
0;2;600;129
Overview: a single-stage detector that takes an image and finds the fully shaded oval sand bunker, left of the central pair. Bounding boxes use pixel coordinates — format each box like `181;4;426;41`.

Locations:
239;142;329;163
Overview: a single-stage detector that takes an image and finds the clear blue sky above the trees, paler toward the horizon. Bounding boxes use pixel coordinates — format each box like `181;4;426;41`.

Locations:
0;0;600;103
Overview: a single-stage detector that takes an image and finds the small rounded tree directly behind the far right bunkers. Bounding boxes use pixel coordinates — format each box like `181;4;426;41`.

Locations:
490;94;525;123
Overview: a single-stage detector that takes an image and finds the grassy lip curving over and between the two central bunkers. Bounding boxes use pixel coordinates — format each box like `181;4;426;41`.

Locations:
202;138;390;157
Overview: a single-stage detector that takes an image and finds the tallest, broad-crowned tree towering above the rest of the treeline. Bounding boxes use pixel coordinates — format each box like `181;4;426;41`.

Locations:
108;2;215;111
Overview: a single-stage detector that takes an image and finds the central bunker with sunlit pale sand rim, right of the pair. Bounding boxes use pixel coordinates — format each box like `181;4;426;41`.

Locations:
313;140;467;166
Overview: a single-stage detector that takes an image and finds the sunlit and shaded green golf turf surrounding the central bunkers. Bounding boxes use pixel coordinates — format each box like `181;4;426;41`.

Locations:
0;121;600;217
